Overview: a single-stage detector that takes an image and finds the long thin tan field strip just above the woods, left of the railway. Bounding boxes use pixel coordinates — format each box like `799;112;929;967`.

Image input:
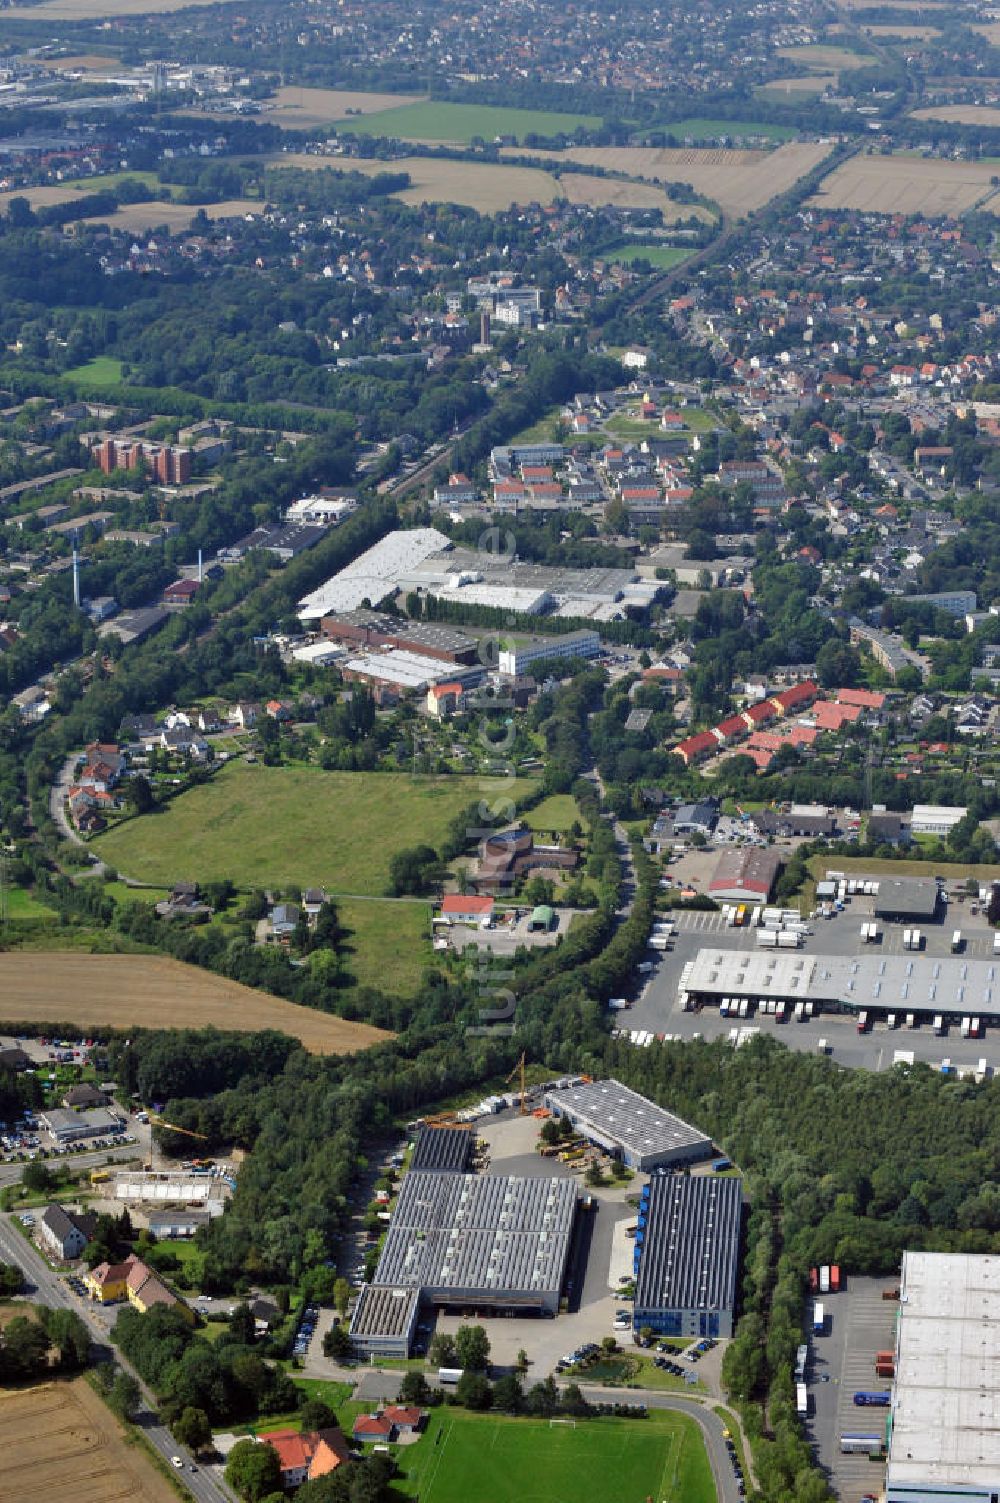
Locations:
269;152;700;224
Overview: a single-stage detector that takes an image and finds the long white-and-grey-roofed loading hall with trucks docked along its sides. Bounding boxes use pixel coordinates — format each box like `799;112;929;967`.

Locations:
684;948;1000;1024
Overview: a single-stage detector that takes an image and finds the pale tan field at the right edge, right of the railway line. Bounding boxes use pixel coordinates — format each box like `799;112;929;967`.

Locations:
811;156;995;215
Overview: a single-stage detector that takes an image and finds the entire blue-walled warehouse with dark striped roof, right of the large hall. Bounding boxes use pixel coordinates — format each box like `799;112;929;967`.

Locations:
633;1174;743;1336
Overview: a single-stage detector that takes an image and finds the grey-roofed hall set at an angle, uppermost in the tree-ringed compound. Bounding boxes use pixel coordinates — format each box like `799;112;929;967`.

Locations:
544;1081;711;1171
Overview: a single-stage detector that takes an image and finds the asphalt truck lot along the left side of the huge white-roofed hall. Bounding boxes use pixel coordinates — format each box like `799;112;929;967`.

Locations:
806;1278;899;1503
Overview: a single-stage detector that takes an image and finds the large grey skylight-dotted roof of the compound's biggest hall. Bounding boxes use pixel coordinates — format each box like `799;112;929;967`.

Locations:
374;1171;576;1296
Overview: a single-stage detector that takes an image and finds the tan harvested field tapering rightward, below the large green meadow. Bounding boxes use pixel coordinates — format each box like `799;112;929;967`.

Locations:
0;950;389;1058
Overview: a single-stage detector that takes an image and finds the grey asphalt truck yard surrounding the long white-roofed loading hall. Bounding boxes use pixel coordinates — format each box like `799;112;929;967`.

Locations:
625;897;1000;1072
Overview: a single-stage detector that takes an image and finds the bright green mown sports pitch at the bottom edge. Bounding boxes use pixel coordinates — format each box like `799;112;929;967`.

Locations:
395;1408;716;1503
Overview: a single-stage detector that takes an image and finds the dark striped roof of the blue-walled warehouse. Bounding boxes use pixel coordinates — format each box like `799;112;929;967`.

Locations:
636;1174;743;1312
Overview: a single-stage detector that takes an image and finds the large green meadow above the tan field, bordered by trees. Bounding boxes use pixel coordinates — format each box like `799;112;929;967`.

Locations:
93;762;532;889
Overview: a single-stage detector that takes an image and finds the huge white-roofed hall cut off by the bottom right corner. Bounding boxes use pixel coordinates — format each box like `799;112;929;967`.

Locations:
886;1252;1000;1503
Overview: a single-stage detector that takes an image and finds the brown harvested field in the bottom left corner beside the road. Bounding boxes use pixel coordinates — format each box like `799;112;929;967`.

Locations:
0;1378;177;1503
